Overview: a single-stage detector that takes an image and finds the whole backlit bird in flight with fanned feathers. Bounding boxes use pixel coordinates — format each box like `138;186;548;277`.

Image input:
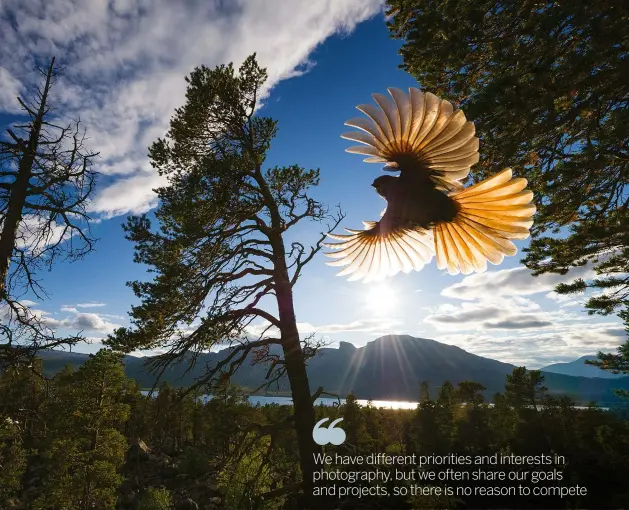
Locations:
323;88;536;282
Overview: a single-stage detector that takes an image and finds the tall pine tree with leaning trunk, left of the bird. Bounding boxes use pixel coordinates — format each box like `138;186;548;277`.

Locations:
108;56;340;504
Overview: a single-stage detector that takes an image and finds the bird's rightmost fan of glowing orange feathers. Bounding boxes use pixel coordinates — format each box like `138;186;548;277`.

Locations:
433;168;536;274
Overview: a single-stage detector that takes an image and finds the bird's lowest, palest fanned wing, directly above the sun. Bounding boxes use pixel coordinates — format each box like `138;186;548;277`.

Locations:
323;221;435;283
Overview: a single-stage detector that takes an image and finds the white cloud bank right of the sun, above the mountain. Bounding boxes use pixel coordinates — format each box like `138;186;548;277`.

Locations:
424;267;626;368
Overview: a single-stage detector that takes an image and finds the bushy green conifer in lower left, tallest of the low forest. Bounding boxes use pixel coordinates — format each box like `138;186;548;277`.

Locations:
33;349;130;510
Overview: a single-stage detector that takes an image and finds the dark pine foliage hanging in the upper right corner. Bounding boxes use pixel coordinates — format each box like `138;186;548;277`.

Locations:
387;0;629;344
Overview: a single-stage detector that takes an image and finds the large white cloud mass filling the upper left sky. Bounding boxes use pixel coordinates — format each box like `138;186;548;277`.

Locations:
0;0;382;217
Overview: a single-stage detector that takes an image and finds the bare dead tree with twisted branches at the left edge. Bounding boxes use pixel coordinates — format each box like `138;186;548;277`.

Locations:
0;58;96;362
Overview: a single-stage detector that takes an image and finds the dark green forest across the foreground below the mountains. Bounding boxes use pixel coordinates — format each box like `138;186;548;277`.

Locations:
0;358;629;510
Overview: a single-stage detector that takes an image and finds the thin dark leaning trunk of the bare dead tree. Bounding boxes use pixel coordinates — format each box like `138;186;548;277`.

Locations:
0;57;55;299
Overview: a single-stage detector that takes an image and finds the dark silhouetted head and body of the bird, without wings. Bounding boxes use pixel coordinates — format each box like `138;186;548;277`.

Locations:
372;162;459;234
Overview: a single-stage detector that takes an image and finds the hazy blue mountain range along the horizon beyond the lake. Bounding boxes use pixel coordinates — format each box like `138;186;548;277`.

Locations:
34;335;629;404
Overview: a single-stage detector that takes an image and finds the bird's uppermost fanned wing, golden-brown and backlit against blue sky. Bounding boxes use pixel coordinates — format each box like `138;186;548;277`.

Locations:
341;88;479;191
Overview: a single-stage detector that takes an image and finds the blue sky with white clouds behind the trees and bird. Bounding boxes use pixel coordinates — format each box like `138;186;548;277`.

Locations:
0;0;625;368
